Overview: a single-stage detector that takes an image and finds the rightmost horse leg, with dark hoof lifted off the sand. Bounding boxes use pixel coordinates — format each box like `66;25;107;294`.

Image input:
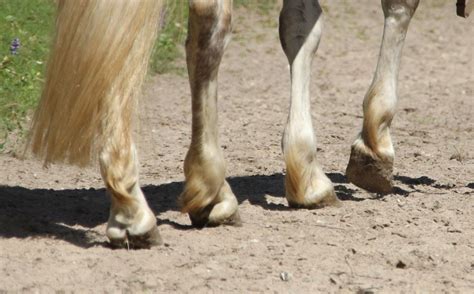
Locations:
346;0;419;193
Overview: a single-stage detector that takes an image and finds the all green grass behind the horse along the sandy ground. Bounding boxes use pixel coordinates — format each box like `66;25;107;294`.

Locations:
0;0;276;151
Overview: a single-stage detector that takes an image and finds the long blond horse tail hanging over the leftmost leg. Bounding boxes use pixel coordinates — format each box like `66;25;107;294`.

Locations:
28;0;162;166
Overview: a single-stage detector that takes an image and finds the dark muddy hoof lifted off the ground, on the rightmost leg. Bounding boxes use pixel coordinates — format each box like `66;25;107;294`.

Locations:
346;145;393;194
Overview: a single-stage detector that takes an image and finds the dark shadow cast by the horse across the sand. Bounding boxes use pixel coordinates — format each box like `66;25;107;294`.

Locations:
0;173;456;248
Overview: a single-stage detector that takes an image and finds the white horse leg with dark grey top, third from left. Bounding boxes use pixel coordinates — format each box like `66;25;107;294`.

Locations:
280;0;338;208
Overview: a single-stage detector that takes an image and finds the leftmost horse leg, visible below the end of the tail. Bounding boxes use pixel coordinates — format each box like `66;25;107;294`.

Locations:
99;131;161;248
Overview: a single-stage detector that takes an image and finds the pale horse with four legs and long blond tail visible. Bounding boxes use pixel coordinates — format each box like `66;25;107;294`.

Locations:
28;0;472;248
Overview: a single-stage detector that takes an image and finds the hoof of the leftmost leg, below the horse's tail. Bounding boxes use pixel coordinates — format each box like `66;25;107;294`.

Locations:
109;225;163;249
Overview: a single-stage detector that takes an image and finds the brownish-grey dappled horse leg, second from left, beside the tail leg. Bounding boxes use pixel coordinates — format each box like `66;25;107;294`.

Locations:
180;0;239;227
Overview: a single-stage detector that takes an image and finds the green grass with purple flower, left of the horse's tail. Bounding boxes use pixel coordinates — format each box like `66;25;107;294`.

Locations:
0;0;55;149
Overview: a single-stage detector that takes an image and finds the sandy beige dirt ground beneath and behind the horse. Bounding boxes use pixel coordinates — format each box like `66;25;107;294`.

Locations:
0;0;474;293
